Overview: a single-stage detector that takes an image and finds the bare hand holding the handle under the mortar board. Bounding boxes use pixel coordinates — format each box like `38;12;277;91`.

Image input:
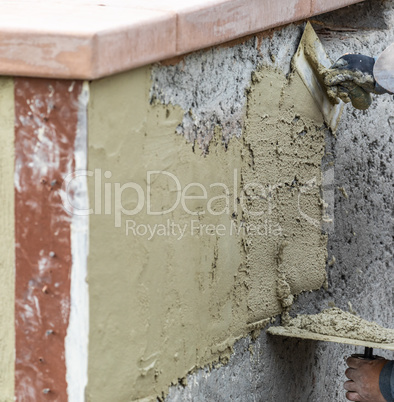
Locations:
344;357;388;402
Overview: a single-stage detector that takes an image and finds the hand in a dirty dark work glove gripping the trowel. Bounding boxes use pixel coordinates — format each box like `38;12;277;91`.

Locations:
324;54;386;110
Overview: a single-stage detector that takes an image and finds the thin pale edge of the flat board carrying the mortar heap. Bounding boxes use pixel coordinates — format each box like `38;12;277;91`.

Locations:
267;327;394;351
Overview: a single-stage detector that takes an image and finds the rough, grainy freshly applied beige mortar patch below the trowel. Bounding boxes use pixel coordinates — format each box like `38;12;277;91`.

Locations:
242;69;327;321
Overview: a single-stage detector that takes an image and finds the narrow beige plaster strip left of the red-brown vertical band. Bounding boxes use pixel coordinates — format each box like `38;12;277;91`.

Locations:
0;78;15;402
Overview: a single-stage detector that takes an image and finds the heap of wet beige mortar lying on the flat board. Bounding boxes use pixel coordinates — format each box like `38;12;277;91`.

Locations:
287;307;394;343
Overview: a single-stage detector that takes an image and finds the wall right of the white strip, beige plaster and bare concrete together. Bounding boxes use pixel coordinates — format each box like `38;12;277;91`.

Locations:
88;2;393;401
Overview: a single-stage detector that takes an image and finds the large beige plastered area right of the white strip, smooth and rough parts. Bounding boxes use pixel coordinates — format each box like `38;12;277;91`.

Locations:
86;67;326;402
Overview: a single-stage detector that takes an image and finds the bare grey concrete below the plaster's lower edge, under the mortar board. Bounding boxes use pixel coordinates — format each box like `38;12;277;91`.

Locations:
166;333;344;402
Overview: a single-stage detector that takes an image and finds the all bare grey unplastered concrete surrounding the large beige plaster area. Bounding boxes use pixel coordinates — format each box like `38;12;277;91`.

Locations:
155;0;394;402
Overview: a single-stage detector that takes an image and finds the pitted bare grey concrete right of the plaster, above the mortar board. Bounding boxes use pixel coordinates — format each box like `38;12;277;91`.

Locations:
296;1;394;352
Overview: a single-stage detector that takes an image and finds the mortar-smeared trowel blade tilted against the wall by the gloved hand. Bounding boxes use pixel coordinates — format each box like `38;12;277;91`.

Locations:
292;22;344;132
